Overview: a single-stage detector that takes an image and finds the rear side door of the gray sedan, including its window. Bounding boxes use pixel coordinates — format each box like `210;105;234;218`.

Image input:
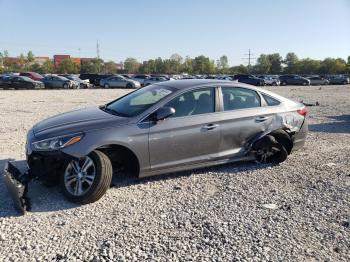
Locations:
218;86;272;158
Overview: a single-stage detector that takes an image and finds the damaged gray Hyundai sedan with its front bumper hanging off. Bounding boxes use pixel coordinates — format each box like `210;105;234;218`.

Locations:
5;80;307;211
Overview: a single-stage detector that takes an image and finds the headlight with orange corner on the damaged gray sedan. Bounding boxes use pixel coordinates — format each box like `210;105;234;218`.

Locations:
32;134;83;151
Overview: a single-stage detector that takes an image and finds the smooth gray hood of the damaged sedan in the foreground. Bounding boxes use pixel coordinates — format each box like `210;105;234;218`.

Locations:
33;107;129;139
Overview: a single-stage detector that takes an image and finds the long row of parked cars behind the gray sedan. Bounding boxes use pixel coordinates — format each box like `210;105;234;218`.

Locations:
0;72;350;89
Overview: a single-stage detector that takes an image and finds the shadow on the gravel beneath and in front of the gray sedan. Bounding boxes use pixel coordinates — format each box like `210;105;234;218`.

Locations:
0;159;272;218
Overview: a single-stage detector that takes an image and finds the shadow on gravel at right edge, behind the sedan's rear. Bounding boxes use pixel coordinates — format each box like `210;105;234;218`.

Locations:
309;115;350;134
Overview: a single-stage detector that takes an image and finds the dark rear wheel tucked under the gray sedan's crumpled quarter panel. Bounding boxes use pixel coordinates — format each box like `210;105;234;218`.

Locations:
253;135;288;164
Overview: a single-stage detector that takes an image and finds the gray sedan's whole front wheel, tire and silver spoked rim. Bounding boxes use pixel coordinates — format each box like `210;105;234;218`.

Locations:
61;150;113;204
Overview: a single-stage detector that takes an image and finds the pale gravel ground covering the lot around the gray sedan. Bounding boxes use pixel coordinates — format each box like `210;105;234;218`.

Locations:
0;86;350;261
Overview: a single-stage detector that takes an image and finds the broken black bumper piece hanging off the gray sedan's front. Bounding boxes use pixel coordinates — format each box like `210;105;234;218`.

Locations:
4;162;33;214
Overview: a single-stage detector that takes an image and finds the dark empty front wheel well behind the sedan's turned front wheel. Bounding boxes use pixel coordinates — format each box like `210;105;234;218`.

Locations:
96;144;140;177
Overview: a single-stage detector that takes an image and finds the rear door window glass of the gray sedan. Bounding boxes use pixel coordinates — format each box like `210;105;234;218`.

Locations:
221;87;261;111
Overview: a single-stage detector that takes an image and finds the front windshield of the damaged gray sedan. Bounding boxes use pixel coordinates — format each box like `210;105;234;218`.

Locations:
104;85;175;117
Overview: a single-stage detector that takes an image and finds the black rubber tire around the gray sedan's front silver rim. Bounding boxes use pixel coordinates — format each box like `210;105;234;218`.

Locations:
60;150;113;204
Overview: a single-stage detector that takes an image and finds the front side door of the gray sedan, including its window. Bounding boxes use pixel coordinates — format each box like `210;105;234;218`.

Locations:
149;87;220;170
